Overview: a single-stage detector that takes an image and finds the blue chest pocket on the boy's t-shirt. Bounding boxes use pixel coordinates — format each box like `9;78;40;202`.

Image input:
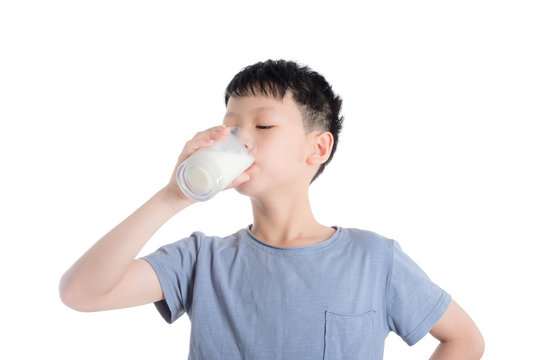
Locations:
324;310;375;360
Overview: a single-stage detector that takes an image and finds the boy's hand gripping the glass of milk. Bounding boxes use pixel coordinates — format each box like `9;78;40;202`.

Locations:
165;125;249;203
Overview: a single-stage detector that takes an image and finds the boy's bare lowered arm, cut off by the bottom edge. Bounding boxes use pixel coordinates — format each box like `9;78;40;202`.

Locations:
430;300;485;360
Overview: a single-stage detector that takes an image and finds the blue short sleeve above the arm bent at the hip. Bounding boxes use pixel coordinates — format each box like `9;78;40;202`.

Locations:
386;240;451;346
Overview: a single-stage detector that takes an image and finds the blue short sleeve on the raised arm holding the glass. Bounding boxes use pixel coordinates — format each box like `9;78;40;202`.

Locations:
142;233;200;324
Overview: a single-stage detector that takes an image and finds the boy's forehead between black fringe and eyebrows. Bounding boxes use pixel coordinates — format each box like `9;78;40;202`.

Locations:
225;94;301;120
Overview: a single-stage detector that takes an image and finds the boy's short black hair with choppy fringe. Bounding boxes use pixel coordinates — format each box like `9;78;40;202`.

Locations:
225;60;343;183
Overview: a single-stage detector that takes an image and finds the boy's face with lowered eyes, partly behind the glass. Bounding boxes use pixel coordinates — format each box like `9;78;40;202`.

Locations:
223;90;318;196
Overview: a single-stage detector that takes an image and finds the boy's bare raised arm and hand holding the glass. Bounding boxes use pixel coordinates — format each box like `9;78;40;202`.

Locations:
60;126;245;311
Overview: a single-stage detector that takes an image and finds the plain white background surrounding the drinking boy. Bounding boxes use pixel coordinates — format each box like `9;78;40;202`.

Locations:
0;0;539;359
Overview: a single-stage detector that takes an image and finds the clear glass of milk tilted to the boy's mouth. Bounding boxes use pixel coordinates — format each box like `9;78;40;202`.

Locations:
176;127;256;201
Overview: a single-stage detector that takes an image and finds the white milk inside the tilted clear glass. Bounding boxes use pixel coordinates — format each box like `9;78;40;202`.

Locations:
186;149;255;194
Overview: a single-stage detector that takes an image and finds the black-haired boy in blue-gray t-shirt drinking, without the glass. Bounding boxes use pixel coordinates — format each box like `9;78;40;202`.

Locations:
60;60;484;360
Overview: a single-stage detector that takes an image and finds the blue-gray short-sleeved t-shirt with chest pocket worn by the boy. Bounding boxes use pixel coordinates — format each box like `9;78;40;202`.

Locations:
143;226;451;360
